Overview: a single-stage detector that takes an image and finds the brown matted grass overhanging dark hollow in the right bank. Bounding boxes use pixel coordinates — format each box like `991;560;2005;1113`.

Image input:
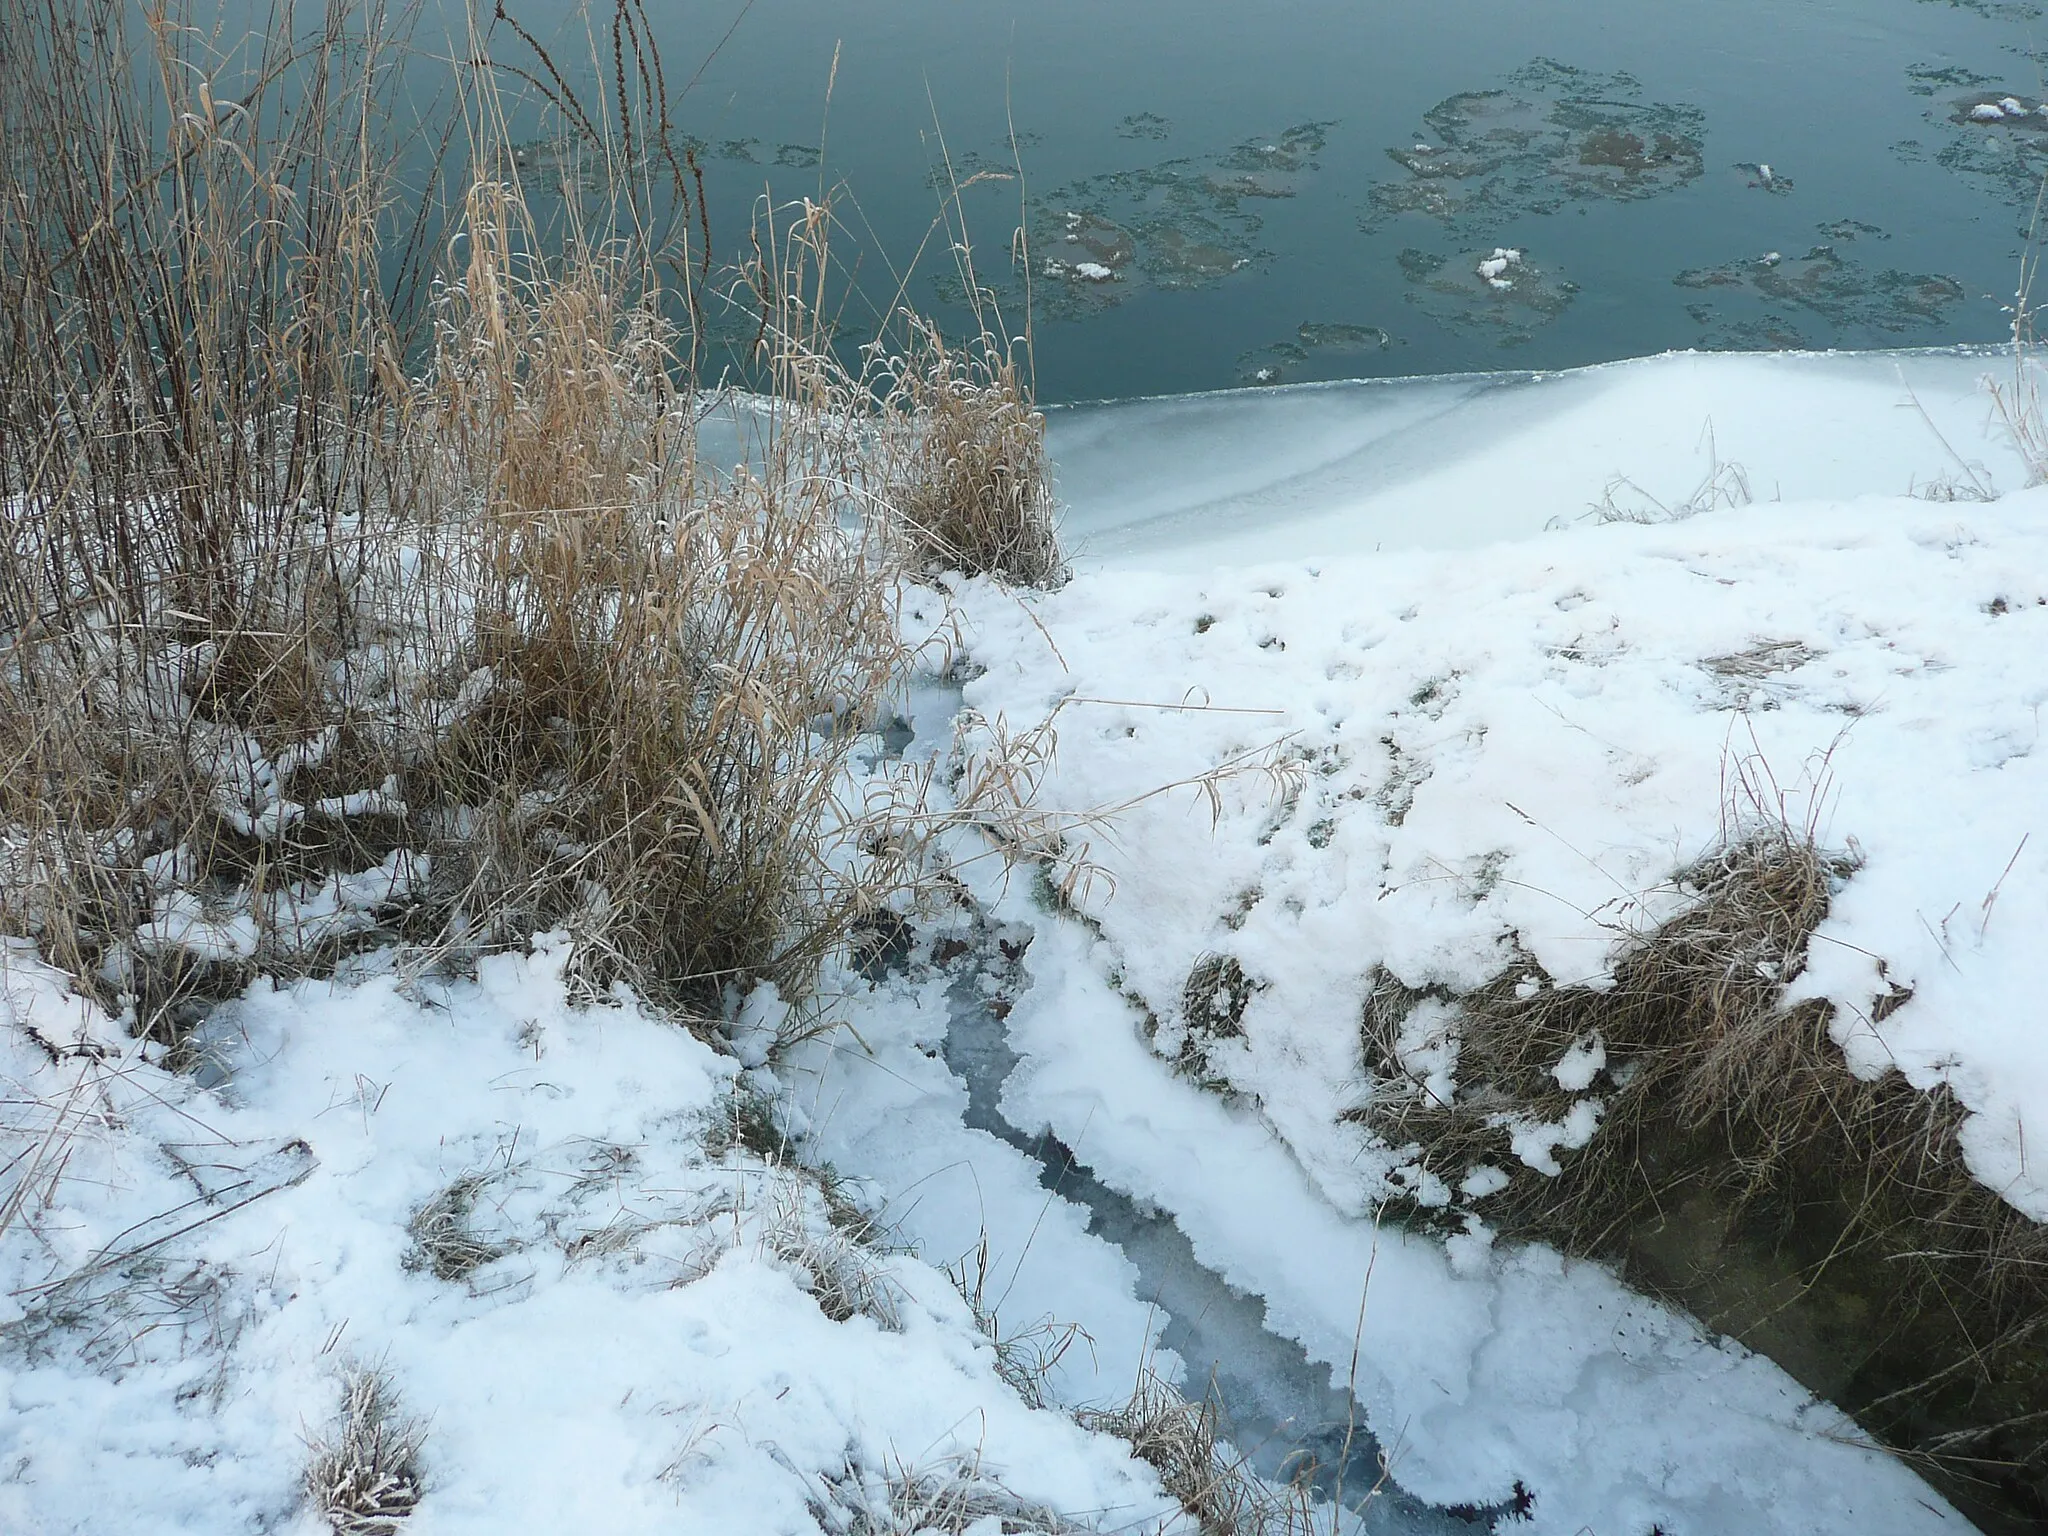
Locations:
1360;825;2048;1518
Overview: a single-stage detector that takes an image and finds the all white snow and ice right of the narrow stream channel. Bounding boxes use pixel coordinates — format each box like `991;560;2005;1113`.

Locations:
946;354;2048;1532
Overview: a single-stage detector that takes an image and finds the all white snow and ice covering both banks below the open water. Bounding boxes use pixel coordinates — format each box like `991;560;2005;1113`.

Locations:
12;348;2048;1536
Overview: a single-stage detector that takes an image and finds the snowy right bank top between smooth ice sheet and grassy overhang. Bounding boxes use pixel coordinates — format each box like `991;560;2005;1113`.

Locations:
969;492;2048;1219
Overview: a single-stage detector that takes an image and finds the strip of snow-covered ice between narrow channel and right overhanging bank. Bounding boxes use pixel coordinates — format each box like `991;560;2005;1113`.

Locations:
974;897;1962;1536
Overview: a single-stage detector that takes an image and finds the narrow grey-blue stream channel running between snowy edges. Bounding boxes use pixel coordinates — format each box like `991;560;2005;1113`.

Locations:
944;971;1516;1536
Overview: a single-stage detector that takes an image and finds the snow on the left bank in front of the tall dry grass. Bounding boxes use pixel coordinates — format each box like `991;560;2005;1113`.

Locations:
0;942;1171;1536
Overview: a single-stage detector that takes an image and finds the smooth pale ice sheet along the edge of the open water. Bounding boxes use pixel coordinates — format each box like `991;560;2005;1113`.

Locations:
1049;348;2025;571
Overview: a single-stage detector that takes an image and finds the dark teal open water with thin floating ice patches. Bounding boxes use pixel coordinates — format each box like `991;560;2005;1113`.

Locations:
464;0;2048;399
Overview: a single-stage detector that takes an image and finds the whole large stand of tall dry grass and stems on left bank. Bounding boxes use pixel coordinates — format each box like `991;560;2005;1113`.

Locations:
0;0;942;1042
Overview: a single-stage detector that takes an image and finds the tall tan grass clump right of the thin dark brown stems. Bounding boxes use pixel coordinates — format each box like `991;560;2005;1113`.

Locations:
403;189;903;1004
